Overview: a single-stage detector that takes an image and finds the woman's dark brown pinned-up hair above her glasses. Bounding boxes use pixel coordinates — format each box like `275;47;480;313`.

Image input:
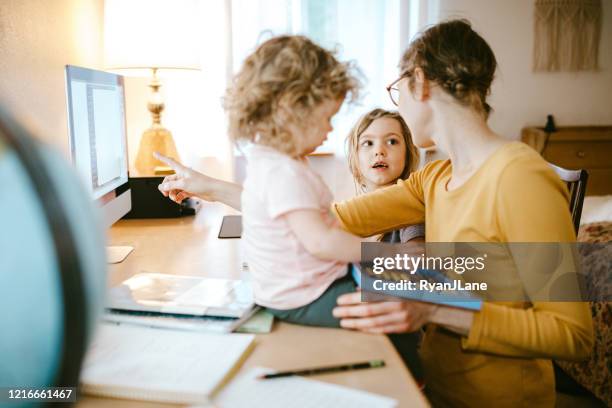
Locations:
400;20;497;118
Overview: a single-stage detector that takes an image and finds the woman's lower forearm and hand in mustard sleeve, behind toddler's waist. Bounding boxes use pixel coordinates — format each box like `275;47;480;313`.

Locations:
333;292;593;360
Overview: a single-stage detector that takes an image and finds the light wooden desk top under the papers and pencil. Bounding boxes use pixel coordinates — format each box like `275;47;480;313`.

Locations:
78;205;428;408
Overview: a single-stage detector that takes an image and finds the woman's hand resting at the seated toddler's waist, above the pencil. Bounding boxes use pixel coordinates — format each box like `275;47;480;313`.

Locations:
333;291;438;333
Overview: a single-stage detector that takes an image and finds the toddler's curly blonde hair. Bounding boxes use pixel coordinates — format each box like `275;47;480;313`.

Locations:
223;35;359;156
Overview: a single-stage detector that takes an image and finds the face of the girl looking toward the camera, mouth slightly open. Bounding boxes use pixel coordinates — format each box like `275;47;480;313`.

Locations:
357;118;406;191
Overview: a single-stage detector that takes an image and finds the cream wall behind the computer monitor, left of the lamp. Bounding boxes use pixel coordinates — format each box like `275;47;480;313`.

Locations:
0;0;104;155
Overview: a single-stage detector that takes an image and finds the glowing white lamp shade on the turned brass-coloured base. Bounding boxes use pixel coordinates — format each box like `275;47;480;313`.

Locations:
104;0;201;73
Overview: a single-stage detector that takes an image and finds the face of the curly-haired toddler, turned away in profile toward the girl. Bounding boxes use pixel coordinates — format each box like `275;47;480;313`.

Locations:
297;98;344;156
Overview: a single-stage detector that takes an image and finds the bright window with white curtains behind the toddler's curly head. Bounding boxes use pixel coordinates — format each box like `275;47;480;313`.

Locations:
148;0;414;187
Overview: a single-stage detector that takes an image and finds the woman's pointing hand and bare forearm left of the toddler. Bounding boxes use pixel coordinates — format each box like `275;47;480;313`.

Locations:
155;153;242;211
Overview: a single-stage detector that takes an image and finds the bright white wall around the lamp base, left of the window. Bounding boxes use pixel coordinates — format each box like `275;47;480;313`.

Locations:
120;1;232;179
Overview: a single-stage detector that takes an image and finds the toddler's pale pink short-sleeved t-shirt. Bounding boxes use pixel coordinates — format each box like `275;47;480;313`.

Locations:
241;145;347;309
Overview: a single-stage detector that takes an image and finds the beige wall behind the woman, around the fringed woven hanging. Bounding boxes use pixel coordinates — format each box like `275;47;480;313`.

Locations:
438;0;612;139
